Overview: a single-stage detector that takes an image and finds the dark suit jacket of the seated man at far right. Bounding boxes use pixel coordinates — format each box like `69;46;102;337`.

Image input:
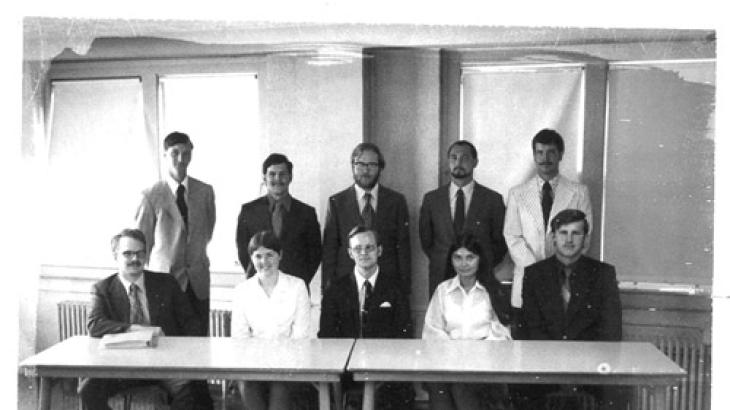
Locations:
522;256;621;341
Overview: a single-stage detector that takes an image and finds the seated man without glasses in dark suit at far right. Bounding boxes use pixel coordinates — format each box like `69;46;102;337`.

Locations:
522;209;621;408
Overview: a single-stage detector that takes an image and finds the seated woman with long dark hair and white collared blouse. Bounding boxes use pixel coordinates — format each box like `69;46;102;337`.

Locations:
422;234;512;410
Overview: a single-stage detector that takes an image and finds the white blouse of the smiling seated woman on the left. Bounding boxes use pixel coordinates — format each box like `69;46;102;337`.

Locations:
231;271;310;339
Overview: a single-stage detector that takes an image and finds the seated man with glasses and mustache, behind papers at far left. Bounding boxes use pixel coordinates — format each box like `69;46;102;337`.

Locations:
79;229;202;410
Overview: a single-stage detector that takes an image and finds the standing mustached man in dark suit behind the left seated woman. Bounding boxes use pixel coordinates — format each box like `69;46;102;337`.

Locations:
236;154;322;285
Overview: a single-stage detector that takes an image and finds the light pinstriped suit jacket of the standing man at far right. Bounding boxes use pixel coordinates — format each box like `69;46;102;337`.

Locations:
504;176;593;307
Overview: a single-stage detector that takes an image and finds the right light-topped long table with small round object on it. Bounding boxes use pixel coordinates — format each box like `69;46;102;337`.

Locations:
347;339;686;410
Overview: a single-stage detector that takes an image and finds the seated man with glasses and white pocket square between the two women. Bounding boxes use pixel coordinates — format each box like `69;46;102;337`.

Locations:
318;225;414;409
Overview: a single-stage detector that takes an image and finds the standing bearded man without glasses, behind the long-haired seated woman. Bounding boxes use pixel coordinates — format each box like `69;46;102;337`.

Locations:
419;140;507;295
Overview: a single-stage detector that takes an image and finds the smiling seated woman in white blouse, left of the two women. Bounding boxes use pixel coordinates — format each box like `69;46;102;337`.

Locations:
231;231;310;410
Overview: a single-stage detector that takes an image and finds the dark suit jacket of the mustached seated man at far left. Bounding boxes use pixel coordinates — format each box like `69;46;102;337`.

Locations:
86;271;200;337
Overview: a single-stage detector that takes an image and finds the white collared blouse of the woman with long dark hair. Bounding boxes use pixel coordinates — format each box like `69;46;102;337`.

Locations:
422;276;512;340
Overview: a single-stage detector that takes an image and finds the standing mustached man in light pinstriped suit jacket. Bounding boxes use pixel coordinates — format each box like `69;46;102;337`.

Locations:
504;129;593;339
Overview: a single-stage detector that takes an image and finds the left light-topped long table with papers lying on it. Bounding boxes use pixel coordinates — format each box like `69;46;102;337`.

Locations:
20;336;354;410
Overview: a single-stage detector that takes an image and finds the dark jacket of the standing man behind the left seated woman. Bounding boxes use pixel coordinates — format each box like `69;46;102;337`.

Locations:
236;196;322;284
